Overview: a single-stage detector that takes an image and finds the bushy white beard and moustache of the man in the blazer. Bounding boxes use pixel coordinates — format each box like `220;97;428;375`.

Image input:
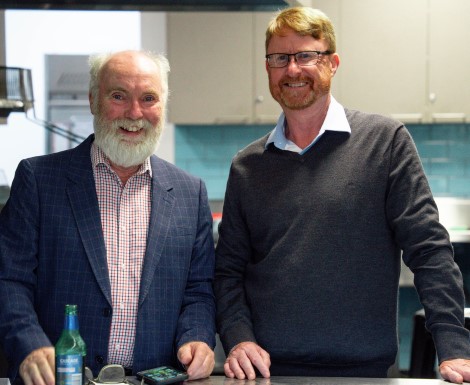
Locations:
93;113;164;167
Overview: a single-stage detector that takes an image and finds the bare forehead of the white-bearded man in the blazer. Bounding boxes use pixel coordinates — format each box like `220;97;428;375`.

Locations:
100;55;161;93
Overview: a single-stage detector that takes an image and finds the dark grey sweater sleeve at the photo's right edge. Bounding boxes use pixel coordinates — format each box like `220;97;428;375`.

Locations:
386;127;470;362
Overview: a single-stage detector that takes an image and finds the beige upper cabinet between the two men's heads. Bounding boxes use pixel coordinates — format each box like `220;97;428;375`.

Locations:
167;12;281;124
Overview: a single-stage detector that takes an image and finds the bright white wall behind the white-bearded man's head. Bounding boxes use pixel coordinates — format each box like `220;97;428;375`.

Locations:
0;10;174;184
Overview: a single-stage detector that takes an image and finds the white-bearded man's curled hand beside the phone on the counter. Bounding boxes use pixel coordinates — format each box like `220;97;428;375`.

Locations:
178;341;215;378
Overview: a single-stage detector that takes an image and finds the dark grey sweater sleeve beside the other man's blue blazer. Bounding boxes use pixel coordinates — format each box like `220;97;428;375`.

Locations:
214;160;256;354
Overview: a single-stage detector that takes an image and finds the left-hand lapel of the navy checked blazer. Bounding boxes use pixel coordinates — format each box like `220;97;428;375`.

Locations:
67;135;112;305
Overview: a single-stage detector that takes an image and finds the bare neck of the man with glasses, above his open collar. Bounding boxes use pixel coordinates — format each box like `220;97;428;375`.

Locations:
284;95;330;149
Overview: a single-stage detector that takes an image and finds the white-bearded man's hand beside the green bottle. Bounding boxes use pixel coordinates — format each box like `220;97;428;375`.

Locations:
20;346;55;385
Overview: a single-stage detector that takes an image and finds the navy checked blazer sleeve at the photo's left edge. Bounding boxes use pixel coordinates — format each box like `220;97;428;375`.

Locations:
0;160;51;376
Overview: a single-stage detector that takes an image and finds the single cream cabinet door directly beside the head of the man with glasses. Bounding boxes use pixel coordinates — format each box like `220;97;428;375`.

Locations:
333;0;427;122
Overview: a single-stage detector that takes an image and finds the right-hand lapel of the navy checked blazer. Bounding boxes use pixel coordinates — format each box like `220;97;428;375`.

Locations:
139;156;175;306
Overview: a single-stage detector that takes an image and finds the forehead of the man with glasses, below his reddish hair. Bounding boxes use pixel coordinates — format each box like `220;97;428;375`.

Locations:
267;28;327;54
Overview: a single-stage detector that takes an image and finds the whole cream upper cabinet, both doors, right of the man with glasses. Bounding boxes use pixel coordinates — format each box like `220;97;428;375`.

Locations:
333;0;470;123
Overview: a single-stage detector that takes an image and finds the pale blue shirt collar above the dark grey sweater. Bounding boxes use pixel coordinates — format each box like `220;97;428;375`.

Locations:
265;95;351;155
